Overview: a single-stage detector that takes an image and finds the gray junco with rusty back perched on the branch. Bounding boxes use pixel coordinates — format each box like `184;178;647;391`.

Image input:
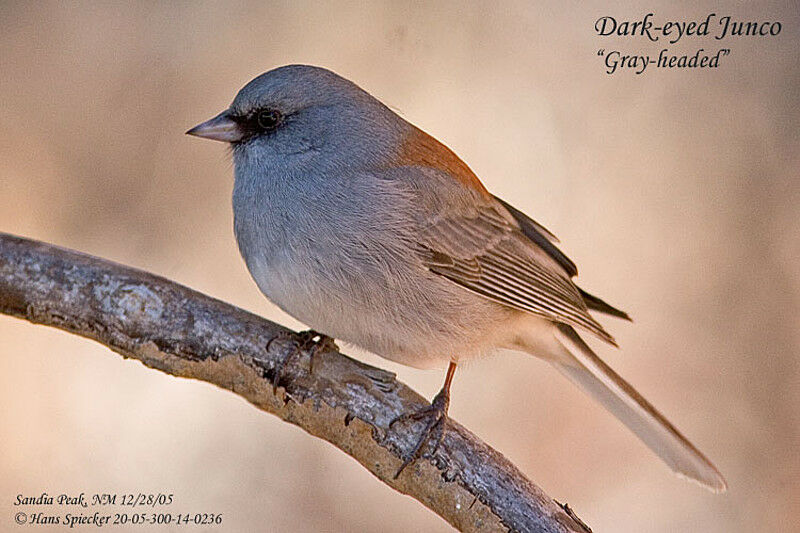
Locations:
186;64;727;492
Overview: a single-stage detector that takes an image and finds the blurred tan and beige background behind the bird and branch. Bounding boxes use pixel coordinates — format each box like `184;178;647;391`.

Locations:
0;0;800;532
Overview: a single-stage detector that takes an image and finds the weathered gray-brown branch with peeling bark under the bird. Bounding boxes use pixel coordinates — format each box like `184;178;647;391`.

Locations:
0;233;589;533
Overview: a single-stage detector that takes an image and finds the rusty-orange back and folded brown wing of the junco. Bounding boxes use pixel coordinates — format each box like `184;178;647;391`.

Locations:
390;126;624;334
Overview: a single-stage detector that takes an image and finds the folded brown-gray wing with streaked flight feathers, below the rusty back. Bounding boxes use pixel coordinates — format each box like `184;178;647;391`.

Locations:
417;197;616;345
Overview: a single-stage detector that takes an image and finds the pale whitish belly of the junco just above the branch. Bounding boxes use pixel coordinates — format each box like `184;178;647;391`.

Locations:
248;250;515;368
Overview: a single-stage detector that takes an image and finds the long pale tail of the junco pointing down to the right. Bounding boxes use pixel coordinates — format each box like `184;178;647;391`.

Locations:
552;325;727;492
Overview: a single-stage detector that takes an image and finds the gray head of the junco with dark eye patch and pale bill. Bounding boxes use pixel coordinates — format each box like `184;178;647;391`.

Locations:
186;65;404;161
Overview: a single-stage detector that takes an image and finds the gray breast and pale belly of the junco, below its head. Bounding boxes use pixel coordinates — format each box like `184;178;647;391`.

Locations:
233;114;522;368
